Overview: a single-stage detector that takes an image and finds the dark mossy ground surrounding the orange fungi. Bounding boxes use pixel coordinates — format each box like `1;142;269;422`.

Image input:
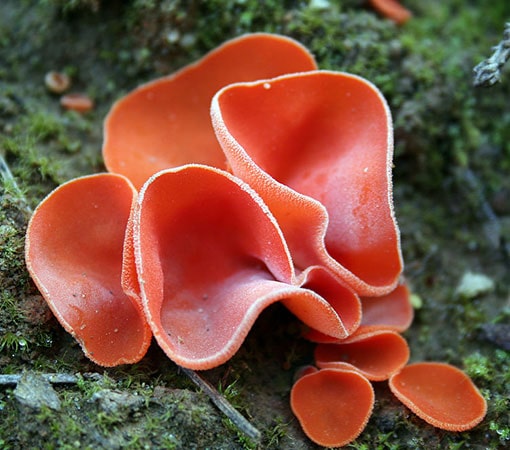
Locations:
0;0;510;449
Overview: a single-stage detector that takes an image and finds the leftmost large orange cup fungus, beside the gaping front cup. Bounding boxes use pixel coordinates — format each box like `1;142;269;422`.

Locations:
25;174;151;366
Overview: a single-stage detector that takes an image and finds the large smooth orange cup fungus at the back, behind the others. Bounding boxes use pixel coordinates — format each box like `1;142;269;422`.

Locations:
103;33;317;188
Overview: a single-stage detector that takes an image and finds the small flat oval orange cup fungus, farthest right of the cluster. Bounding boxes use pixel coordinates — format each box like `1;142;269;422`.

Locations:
389;362;487;431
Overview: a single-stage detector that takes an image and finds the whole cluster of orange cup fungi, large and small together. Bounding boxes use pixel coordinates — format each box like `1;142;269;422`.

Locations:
26;33;485;446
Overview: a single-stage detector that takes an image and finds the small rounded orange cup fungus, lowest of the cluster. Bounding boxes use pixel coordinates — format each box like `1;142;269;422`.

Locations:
290;369;374;447
